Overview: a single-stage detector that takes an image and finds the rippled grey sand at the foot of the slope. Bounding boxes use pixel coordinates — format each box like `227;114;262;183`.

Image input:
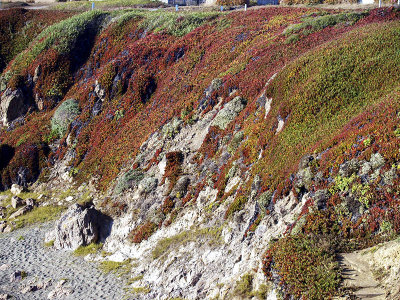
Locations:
0;224;125;300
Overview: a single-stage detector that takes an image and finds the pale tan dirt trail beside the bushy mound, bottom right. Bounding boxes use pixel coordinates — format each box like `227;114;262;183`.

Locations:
339;252;386;300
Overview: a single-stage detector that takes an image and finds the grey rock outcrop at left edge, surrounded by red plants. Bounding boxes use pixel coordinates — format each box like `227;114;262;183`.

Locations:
0;89;30;126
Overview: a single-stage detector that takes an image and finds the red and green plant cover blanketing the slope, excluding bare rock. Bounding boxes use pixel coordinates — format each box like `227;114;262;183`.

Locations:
0;7;400;299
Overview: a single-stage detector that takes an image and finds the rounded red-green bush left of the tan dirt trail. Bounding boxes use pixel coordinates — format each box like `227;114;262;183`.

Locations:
263;234;340;299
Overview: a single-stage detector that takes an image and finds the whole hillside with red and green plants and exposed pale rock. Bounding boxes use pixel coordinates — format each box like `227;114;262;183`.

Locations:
0;7;400;299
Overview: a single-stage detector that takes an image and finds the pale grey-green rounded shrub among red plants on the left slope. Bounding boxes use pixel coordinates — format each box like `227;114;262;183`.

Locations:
51;99;79;137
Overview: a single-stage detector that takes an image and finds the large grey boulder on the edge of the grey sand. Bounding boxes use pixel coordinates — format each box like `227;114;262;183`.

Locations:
46;204;111;250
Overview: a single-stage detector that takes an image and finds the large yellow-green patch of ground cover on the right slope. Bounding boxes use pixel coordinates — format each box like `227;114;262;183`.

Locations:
255;22;400;188
